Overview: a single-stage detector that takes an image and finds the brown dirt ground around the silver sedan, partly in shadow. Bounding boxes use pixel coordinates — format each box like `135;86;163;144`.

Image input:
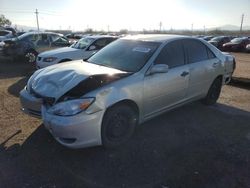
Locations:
0;54;250;188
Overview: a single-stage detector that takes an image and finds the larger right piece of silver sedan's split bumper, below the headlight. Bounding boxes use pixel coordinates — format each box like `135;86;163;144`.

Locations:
42;105;104;148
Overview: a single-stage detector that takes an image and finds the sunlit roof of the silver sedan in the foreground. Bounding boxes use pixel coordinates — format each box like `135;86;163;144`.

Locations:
123;34;190;42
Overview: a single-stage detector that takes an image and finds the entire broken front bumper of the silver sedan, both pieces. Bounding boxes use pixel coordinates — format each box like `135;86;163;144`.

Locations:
20;89;104;148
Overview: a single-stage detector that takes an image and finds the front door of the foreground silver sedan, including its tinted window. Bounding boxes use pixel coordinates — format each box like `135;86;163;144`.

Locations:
144;40;189;118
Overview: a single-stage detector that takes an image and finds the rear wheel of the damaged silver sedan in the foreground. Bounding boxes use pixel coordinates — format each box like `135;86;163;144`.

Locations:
202;78;222;105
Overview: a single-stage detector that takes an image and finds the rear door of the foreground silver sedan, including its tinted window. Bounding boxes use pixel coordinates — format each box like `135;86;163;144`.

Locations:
183;39;221;99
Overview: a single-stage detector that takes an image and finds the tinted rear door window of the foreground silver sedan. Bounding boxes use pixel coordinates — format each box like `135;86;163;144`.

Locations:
184;39;209;63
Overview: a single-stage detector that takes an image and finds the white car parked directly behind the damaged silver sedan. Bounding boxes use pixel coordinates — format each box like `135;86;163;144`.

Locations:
36;35;117;69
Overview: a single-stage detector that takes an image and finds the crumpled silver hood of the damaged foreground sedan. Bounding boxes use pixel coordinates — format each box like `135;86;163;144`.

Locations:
28;60;126;100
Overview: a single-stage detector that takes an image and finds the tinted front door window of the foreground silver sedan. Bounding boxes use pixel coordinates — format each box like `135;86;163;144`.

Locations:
155;40;185;68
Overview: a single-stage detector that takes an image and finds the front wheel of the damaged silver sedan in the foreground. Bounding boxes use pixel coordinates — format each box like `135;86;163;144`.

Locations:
101;105;138;148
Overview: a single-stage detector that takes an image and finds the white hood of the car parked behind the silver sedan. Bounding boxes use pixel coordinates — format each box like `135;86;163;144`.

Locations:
39;47;81;57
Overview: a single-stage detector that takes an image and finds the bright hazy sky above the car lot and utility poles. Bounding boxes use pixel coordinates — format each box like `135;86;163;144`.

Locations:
0;0;250;30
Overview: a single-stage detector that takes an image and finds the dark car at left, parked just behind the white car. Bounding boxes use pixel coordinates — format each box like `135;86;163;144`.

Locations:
3;32;70;63
